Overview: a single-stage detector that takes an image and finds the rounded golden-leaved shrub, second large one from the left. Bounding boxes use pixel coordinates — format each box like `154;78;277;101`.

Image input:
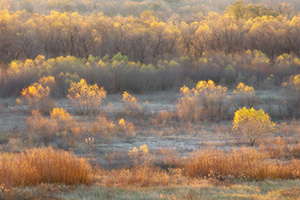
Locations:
68;79;106;115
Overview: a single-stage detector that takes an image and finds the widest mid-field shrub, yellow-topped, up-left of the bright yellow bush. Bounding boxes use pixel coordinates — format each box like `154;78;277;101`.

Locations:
176;80;227;121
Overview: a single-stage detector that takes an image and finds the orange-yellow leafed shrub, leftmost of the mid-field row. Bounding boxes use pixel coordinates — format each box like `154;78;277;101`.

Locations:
21;77;55;113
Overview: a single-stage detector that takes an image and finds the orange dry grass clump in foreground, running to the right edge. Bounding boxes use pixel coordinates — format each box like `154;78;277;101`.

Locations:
184;148;300;180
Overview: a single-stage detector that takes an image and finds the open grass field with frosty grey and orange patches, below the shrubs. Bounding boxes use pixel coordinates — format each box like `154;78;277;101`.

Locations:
0;87;300;199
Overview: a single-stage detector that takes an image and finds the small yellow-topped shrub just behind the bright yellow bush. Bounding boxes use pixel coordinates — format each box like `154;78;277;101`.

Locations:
233;83;257;108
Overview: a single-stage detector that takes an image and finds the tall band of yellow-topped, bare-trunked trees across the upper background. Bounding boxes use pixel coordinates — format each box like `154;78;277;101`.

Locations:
0;2;300;64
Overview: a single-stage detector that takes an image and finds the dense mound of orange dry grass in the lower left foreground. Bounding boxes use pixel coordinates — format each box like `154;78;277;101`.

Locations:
0;147;92;186
